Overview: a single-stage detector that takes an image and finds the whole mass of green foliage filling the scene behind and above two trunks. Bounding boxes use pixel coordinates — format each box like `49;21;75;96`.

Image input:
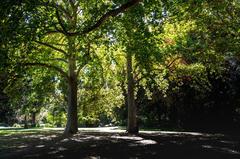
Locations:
0;0;240;132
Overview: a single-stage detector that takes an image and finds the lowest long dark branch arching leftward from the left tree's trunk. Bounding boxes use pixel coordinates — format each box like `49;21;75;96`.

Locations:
21;62;69;80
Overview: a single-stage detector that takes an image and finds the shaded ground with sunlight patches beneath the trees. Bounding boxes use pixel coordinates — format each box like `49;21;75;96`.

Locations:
0;129;240;159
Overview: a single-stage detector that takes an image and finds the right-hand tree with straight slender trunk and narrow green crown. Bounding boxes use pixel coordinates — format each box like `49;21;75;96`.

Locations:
112;0;164;134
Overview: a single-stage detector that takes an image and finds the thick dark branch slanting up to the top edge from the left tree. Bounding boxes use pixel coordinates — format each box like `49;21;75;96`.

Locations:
68;0;142;36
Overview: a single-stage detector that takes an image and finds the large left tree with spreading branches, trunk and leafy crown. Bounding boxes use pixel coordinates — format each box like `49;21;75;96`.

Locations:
1;0;140;134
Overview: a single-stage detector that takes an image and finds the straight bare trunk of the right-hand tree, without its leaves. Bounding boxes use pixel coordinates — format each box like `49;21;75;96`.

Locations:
127;53;138;134
